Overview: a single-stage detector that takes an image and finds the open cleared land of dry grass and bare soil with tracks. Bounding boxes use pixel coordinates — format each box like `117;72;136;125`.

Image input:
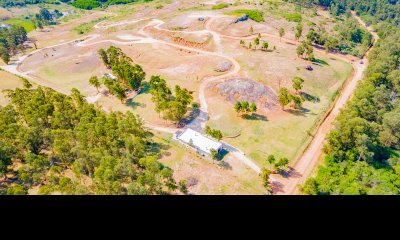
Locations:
0;1;362;194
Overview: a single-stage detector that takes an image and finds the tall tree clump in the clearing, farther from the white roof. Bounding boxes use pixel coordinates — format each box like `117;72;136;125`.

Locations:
96;46;146;102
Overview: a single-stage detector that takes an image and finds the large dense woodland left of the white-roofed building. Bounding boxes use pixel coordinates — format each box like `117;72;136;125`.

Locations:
0;80;186;194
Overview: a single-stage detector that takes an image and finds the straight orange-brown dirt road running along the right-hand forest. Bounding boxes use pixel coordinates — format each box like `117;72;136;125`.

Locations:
272;12;379;195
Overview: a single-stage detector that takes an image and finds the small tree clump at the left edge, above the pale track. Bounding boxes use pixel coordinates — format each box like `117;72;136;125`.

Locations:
0;25;28;64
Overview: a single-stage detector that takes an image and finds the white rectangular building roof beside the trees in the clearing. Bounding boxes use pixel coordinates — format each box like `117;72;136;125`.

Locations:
178;128;222;153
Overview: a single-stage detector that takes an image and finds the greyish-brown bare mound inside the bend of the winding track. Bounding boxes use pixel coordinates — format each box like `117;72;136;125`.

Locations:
217;78;278;110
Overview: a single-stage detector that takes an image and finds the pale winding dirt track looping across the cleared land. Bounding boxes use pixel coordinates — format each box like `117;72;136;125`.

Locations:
1;14;261;174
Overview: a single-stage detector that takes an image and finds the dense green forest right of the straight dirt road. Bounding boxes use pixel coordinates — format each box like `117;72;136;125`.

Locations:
302;0;400;194
